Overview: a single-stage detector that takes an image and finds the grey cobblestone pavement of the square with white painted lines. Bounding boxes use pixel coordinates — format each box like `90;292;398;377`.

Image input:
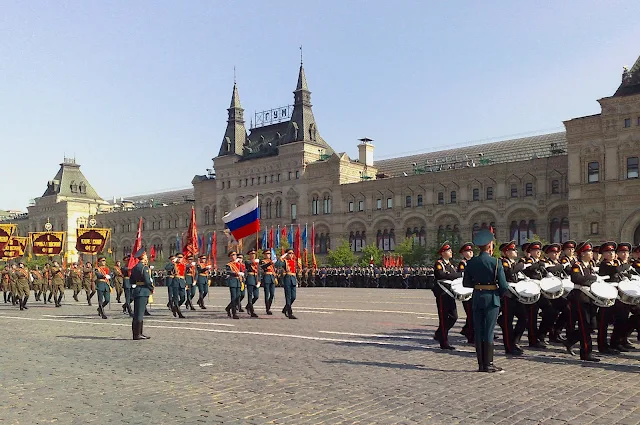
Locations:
0;288;640;425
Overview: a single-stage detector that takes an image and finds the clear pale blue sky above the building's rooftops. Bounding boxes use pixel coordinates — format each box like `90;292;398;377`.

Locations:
0;0;640;210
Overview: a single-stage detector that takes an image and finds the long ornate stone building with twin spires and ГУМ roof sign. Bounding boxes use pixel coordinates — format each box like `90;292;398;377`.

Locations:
5;54;640;261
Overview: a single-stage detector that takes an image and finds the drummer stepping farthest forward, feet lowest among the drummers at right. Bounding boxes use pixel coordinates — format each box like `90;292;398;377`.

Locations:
565;241;600;362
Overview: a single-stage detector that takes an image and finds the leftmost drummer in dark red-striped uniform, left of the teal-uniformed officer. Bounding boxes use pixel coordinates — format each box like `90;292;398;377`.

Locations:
433;241;460;350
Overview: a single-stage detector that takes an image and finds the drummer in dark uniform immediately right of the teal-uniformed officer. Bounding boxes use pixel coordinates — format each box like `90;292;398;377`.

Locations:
498;241;527;356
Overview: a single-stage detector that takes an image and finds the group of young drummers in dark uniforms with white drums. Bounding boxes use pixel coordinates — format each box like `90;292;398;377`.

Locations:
433;241;640;362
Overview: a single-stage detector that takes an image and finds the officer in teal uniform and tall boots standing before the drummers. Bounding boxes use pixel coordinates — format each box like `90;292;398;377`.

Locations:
462;229;508;373
